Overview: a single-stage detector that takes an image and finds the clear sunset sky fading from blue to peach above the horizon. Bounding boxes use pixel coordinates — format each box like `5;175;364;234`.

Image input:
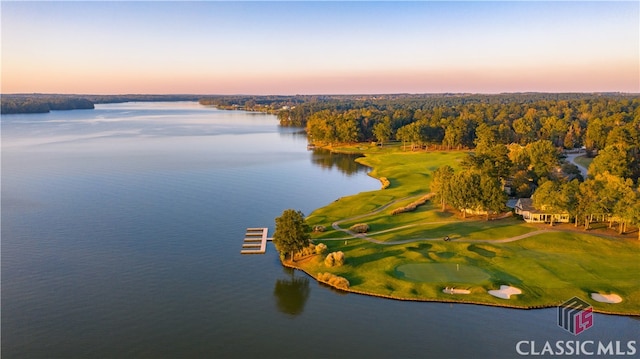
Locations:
1;1;640;94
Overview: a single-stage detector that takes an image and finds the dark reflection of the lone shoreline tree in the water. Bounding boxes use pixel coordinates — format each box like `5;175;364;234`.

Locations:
273;268;310;316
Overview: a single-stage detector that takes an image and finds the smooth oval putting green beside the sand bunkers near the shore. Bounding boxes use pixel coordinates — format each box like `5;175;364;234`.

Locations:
396;263;490;284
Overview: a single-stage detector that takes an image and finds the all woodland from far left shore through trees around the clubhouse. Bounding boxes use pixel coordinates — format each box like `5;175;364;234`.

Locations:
2;93;640;232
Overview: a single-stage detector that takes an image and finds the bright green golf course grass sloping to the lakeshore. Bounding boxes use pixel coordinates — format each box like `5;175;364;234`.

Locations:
297;146;640;315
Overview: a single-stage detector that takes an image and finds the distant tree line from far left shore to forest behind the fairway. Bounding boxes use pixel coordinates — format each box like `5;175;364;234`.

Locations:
2;93;640;186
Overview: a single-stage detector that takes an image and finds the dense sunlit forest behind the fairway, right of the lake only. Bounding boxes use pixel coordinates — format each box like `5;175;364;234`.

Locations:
286;94;640;180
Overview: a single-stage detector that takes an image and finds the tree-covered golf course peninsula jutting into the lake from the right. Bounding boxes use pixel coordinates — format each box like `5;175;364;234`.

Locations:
262;94;640;315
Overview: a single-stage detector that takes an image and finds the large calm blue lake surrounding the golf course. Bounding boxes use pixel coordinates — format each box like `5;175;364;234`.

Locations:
1;102;640;358
